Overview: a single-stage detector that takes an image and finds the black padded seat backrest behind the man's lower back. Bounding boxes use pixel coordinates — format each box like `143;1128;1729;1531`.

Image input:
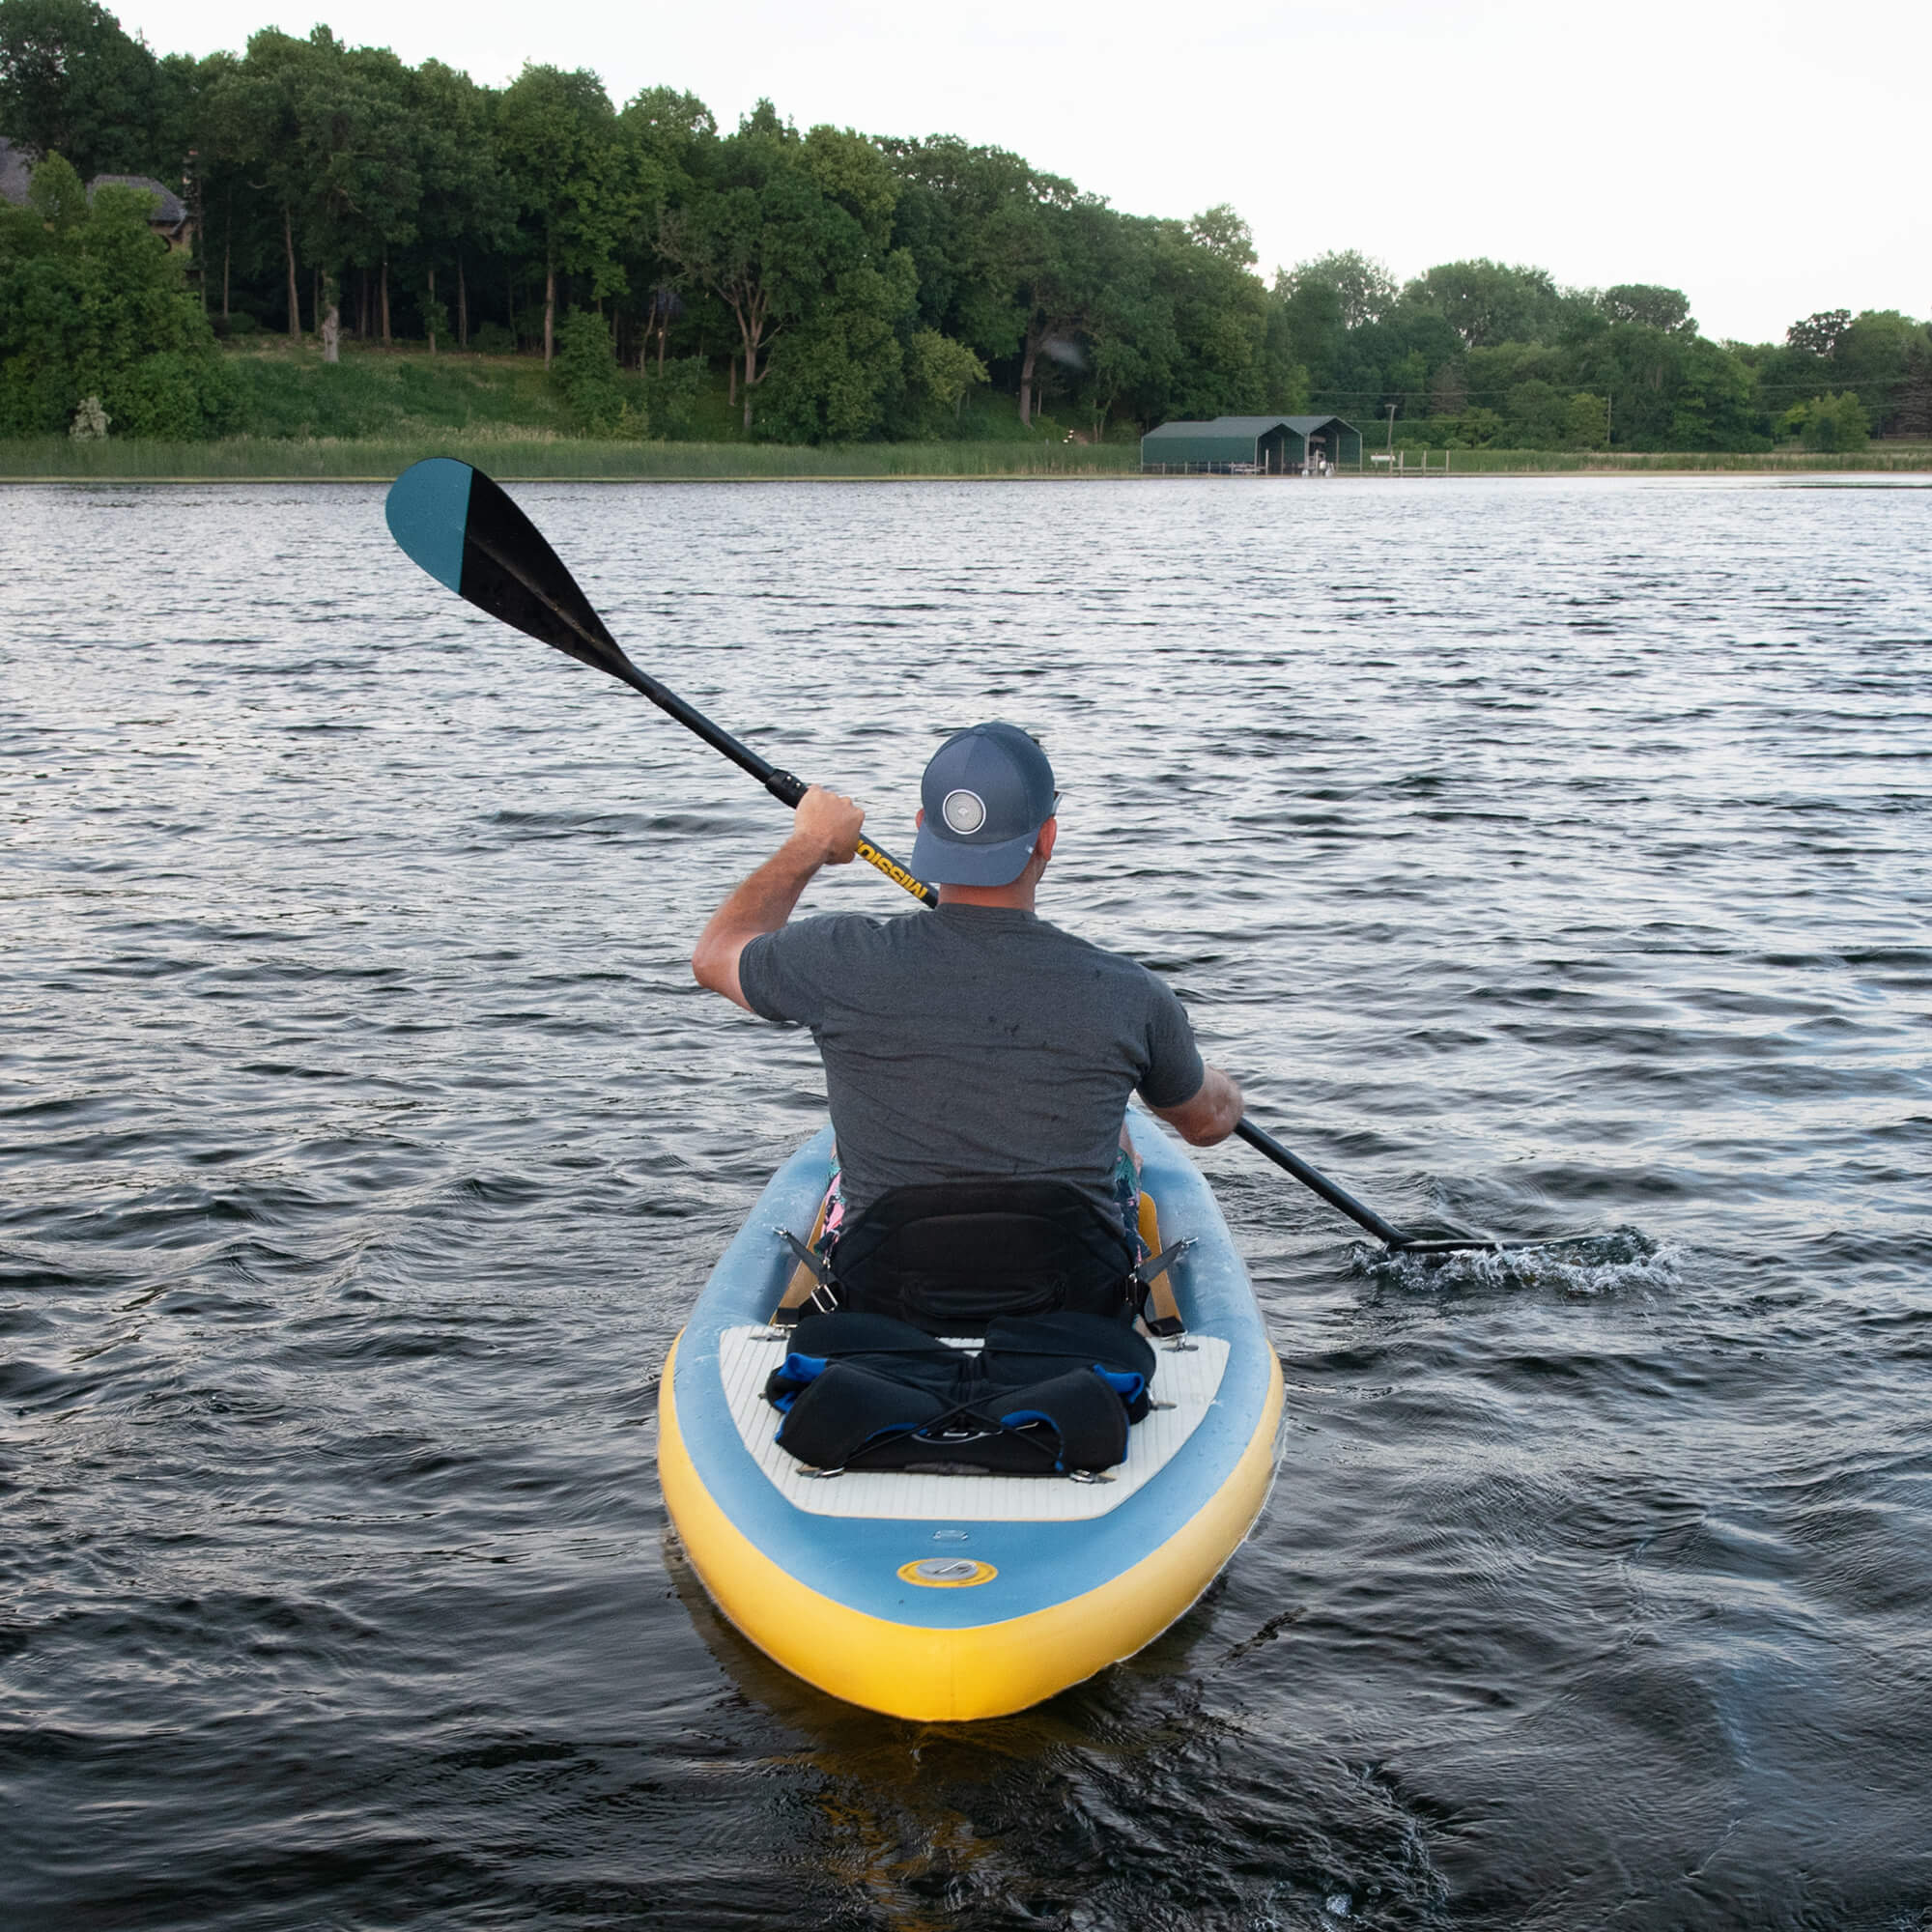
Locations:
831;1179;1134;1335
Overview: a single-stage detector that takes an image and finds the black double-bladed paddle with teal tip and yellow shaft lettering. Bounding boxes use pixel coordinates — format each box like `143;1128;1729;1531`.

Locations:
388;456;1548;1256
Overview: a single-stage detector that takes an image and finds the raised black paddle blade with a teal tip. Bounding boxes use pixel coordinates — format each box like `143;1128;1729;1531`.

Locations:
386;456;634;684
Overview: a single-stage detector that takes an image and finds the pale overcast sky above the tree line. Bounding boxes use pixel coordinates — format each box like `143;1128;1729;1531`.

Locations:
108;0;1932;340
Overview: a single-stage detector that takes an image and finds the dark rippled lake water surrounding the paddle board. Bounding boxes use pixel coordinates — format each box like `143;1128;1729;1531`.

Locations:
0;479;1932;1932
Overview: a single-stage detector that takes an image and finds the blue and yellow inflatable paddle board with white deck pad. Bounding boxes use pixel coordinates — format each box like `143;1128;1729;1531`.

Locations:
657;1124;1281;1721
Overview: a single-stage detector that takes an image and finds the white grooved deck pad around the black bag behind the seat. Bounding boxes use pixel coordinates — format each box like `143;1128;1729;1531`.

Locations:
719;1327;1229;1522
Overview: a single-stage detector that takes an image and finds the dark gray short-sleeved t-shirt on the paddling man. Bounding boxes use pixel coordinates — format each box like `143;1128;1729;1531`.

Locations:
738;906;1206;1217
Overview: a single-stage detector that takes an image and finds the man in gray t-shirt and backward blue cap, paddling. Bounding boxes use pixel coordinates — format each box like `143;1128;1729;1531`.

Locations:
692;723;1240;1235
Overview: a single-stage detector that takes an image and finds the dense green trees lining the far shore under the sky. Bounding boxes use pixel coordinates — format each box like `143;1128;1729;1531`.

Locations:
0;0;1932;450
